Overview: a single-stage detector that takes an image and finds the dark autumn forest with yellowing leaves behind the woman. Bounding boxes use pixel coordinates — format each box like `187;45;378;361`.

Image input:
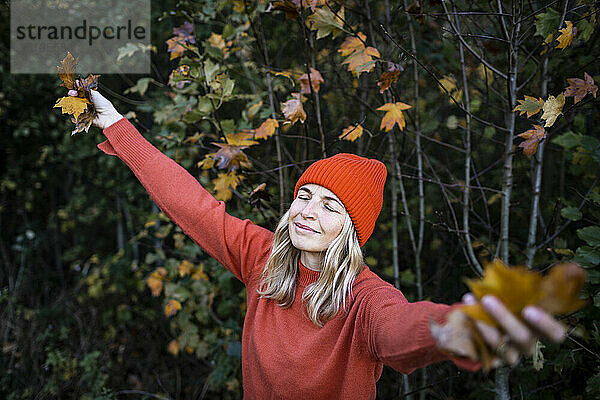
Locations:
0;0;600;400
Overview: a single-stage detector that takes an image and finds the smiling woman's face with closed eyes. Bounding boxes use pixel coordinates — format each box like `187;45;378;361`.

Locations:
289;183;347;253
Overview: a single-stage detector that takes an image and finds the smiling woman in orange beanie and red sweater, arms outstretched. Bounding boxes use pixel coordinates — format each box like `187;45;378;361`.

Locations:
86;91;564;400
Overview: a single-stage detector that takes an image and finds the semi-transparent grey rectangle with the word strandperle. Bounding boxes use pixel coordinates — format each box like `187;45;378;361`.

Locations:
10;0;151;74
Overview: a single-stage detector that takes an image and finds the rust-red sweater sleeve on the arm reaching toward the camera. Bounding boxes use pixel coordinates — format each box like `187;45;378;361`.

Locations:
365;285;480;374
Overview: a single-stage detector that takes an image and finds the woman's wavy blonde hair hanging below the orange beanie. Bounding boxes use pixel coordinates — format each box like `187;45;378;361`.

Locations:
257;210;364;327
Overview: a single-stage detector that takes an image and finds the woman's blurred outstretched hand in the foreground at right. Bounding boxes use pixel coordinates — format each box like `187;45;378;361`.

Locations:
431;293;566;369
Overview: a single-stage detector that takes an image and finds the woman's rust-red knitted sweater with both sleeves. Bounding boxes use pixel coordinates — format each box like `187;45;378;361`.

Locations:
98;118;478;400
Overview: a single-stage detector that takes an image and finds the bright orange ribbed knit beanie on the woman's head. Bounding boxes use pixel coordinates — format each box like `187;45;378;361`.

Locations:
294;153;387;247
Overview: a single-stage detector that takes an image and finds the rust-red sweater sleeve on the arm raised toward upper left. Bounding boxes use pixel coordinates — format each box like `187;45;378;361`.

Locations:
98;118;273;285
